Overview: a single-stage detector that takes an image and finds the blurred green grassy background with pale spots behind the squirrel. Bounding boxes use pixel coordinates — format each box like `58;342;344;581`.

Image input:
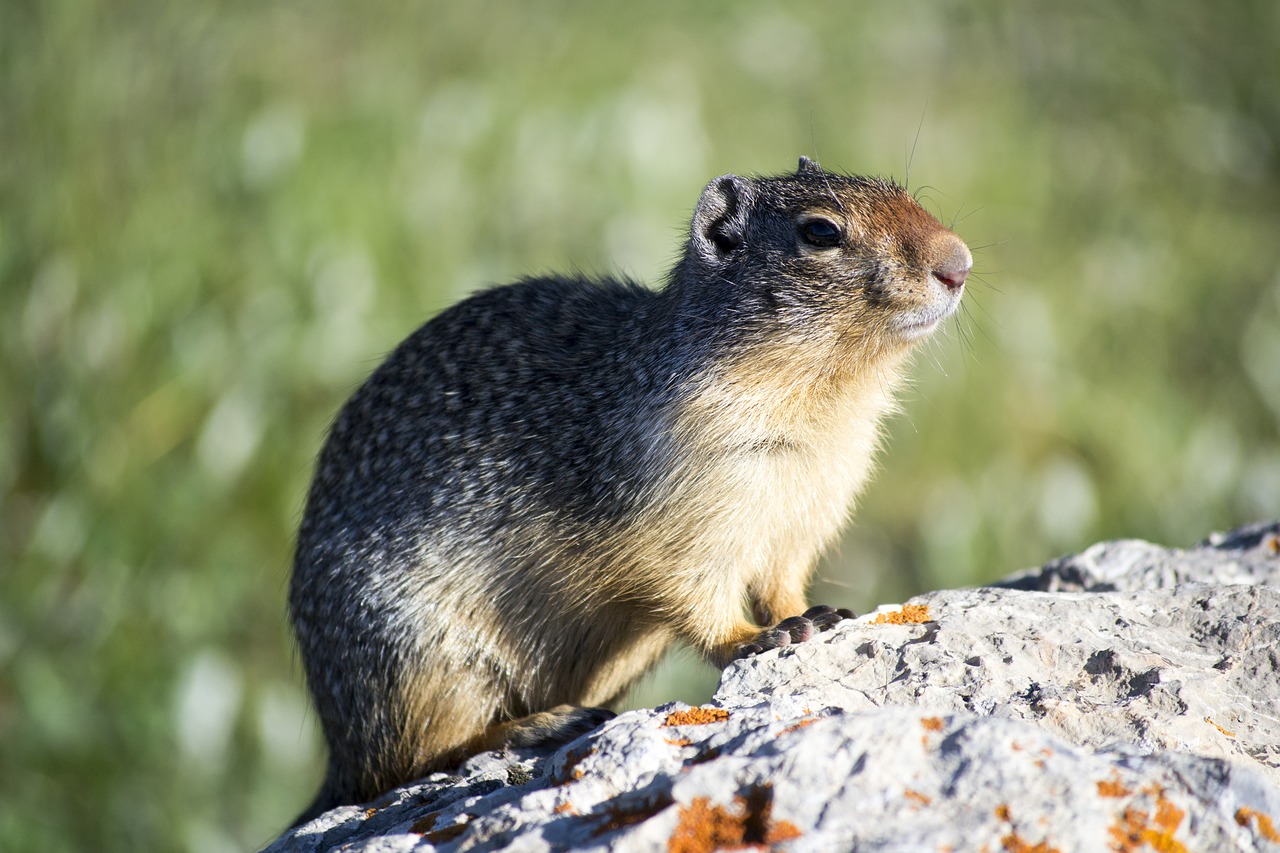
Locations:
0;0;1280;850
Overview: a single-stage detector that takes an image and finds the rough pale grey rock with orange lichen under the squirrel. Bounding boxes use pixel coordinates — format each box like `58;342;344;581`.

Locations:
270;523;1280;853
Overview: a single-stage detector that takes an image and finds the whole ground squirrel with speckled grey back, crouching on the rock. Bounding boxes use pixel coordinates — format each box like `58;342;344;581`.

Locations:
289;158;972;820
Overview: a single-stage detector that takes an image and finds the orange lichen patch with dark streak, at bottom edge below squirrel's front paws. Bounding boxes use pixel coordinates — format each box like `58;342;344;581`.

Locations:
667;785;801;853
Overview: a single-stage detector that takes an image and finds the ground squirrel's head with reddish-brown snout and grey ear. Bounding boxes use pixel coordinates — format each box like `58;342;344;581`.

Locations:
677;158;973;348
